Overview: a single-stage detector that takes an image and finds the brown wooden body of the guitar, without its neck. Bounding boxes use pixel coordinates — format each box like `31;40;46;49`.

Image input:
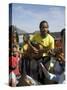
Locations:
23;44;43;60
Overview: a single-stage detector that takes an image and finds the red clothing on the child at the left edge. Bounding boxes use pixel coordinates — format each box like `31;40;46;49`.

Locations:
9;55;20;75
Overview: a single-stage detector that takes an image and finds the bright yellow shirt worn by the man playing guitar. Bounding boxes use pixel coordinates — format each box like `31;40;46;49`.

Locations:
30;33;54;56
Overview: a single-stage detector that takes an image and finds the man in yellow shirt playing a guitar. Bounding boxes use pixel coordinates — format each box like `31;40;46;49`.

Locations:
31;21;54;81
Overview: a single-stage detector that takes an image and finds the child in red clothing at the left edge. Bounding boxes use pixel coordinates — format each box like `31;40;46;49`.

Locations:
9;45;20;86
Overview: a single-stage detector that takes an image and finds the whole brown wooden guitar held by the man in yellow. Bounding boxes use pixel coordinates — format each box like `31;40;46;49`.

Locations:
22;41;64;61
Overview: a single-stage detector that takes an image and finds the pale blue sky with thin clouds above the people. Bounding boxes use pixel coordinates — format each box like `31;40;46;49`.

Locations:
9;3;65;33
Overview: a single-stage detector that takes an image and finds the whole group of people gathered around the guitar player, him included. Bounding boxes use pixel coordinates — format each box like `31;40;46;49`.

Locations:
9;20;65;86
